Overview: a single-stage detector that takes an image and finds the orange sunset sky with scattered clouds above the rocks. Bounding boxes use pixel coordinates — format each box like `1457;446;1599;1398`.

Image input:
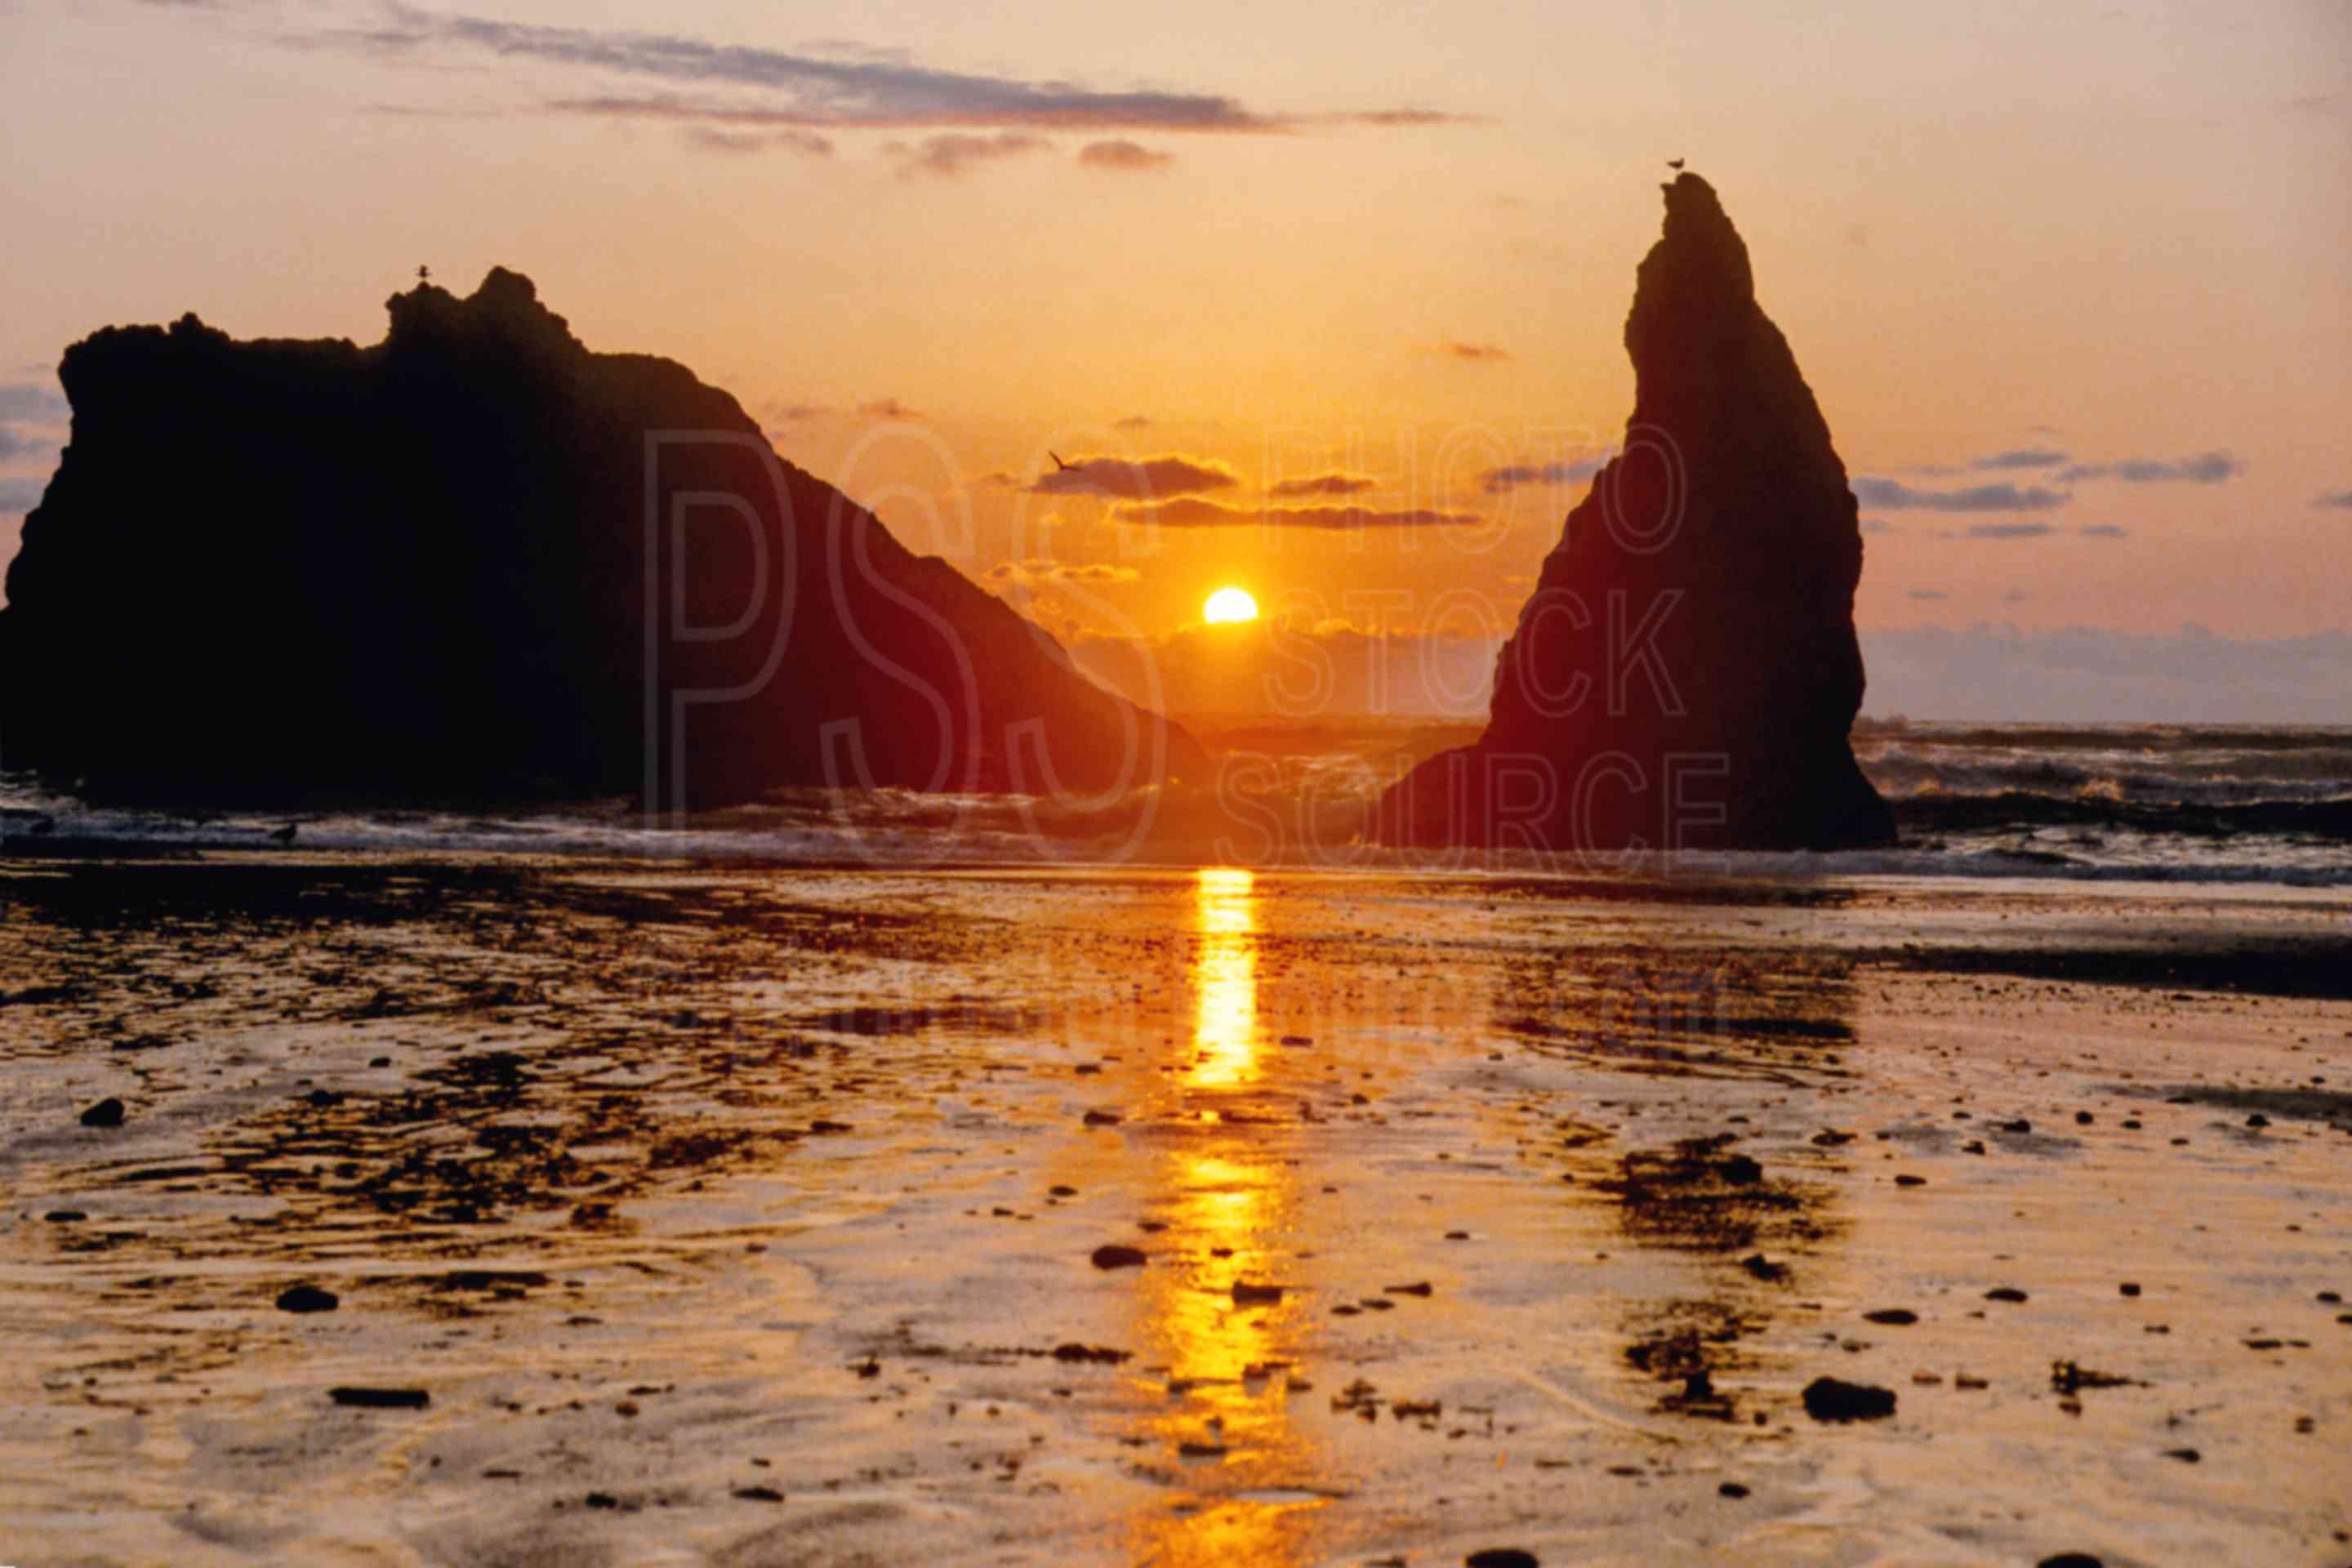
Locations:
0;0;2352;722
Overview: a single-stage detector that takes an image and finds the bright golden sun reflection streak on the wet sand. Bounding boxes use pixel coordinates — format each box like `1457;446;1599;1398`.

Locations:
1134;867;1324;1566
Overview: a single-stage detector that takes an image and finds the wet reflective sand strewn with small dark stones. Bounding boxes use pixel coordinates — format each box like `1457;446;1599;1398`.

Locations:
0;851;2352;1563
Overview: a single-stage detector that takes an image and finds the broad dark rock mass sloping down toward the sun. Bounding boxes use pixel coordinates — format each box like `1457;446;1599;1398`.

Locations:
0;270;1206;806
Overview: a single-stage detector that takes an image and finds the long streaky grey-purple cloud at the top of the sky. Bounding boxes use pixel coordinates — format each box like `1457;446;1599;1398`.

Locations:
313;0;1460;134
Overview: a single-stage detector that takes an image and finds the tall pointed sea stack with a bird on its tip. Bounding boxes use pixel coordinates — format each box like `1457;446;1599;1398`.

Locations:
1374;174;1893;851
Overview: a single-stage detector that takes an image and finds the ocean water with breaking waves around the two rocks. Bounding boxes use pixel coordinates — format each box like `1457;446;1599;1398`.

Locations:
0;717;2352;886
